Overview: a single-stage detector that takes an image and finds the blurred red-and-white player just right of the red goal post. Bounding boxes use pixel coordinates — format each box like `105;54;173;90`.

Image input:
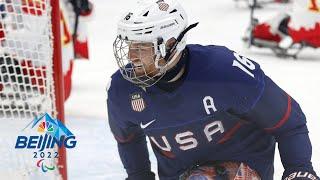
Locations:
60;0;93;99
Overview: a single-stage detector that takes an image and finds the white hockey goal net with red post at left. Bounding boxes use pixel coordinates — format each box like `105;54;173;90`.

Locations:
0;0;67;179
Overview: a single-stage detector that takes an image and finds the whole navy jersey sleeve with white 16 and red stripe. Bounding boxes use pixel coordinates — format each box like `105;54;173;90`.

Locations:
218;48;316;179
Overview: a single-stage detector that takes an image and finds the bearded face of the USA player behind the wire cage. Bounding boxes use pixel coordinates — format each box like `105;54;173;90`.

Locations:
128;42;164;76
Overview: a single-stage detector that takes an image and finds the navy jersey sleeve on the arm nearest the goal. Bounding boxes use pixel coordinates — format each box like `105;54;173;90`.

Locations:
107;76;154;180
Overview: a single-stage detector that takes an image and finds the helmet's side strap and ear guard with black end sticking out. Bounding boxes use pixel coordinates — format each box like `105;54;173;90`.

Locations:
155;22;199;75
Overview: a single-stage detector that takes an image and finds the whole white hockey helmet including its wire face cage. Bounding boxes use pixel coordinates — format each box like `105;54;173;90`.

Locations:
113;0;188;87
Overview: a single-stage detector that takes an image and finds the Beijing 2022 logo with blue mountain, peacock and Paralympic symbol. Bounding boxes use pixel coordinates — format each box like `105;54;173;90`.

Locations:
15;113;77;172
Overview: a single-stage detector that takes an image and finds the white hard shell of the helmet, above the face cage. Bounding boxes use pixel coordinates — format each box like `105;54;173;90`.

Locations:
118;0;188;48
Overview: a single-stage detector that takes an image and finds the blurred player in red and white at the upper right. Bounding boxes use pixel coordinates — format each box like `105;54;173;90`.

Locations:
248;0;320;49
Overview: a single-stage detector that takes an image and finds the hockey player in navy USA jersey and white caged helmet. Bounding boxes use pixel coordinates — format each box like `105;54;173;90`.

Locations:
107;0;318;180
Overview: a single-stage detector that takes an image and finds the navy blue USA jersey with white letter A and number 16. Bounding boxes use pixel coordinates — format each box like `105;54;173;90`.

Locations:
107;45;313;180
